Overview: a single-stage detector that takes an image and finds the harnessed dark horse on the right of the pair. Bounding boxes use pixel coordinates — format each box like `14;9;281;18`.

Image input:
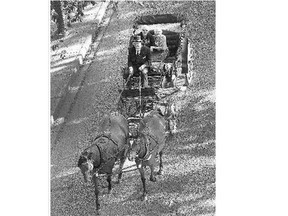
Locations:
128;110;165;200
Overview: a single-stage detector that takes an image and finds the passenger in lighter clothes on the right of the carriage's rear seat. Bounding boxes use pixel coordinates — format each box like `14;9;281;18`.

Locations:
150;29;169;61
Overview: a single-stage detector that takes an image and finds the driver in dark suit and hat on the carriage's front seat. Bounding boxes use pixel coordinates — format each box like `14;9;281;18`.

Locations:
124;35;151;88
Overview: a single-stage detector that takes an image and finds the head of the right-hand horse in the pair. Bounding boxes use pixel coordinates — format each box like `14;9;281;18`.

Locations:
128;133;149;161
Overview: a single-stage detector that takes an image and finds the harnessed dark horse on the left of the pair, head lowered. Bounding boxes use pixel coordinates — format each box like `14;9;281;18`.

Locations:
78;113;129;212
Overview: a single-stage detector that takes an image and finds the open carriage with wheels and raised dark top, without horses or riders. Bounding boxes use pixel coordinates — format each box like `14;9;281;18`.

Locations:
118;14;192;135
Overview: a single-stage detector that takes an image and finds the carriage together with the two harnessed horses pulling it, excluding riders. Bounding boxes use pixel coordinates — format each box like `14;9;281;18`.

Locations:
78;14;192;214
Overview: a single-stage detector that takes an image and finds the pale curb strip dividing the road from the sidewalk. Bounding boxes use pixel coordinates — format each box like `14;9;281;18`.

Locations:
50;1;110;124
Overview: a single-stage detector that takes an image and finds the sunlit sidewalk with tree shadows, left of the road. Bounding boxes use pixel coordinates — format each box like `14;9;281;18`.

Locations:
50;1;109;123
